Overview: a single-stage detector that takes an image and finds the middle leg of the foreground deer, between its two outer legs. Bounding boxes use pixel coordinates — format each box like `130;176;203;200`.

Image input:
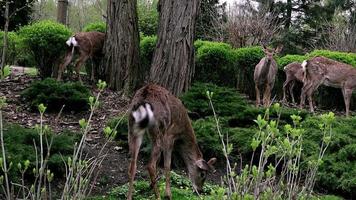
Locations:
147;143;161;199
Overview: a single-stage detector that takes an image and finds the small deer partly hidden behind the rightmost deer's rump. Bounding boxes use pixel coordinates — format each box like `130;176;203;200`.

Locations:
282;62;304;103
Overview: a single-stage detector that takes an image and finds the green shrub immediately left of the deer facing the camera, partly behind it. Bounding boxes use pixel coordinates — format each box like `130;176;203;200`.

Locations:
235;47;264;98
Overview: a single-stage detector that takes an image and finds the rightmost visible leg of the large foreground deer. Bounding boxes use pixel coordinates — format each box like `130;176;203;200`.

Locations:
163;140;173;200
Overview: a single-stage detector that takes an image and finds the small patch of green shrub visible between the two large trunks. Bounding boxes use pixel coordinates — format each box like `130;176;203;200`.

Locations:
140;36;157;72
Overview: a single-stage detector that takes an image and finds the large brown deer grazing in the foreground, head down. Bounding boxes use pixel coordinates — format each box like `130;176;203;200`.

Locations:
127;84;216;200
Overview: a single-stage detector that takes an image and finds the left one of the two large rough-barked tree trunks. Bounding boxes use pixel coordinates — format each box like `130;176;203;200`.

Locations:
104;0;145;95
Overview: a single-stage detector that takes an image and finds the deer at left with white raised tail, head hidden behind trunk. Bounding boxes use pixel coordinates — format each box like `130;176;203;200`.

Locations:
57;31;105;82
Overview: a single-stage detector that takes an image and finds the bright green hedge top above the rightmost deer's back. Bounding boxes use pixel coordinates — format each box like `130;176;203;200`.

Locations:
307;50;356;67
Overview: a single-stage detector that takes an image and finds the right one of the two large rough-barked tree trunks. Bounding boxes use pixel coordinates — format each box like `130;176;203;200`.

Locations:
150;0;200;95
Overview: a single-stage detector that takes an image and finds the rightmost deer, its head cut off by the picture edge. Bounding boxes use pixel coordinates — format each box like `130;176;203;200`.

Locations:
300;56;356;116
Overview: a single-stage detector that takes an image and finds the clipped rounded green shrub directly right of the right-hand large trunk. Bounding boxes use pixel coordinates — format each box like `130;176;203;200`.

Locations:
194;42;236;86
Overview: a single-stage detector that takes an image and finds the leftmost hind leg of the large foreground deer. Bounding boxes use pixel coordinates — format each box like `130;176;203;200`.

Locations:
127;133;142;200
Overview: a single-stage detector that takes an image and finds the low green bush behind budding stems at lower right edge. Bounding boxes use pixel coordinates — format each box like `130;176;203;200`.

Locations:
302;117;356;198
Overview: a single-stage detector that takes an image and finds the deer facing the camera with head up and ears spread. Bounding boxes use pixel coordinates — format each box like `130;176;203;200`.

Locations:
253;45;283;107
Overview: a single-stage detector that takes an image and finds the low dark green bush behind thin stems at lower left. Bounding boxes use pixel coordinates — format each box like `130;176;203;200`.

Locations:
4;124;80;180
